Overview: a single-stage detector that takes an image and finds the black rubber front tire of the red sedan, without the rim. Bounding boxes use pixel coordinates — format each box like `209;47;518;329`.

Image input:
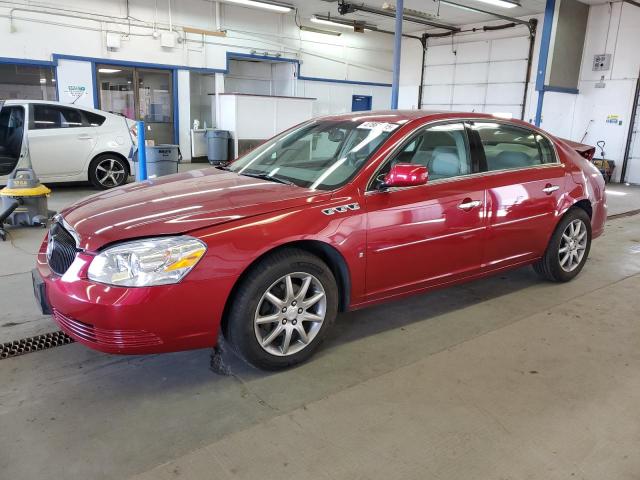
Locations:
225;248;338;370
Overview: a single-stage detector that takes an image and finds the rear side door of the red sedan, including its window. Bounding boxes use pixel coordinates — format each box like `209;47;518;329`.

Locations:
469;121;565;270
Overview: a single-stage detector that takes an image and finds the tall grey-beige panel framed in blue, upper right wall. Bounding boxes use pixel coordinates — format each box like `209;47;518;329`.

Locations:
544;0;589;93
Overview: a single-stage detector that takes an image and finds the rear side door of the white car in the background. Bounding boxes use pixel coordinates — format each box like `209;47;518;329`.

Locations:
29;103;97;177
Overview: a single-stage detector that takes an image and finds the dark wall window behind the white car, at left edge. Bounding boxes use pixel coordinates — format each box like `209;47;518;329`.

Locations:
0;63;57;100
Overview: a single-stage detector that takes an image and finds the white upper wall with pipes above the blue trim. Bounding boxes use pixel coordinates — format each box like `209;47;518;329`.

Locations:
0;0;393;83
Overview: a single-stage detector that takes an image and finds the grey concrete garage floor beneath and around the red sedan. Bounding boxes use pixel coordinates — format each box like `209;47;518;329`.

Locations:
0;173;640;480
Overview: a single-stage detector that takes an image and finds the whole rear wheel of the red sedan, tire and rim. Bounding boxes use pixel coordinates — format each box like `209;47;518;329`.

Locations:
533;208;591;282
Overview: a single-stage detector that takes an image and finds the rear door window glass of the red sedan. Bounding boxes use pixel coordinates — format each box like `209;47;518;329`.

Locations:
472;122;555;171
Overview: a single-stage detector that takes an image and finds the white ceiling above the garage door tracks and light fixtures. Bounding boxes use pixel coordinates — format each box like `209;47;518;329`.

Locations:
290;0;544;33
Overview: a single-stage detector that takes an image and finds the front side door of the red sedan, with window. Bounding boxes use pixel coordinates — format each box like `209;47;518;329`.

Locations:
366;123;485;298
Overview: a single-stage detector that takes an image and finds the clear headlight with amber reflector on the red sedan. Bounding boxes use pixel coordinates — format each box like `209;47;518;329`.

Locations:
89;236;207;287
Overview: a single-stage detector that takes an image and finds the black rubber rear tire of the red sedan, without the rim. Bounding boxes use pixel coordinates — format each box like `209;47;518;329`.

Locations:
533;207;591;282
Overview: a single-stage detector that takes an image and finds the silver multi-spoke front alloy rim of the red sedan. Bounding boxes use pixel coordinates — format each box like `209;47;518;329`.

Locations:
253;272;327;356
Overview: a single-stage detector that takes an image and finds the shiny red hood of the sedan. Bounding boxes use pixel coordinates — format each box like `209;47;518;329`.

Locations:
61;168;331;251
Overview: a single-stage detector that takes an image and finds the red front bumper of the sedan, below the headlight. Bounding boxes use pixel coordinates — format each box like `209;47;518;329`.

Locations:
33;243;233;354
